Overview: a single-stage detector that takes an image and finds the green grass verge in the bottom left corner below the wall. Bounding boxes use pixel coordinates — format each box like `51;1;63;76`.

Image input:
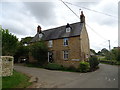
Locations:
2;71;32;88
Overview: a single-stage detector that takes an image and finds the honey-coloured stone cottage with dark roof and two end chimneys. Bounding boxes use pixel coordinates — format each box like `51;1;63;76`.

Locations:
30;12;90;67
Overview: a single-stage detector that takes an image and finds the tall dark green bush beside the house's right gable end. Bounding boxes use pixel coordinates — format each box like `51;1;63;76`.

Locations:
89;56;99;71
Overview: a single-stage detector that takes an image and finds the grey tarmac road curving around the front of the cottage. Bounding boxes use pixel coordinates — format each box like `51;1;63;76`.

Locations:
14;64;118;88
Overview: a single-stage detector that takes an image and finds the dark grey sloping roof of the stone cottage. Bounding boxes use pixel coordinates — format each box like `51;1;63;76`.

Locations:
31;22;83;42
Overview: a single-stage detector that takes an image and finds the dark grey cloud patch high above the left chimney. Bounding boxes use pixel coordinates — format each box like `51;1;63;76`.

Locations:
24;2;57;26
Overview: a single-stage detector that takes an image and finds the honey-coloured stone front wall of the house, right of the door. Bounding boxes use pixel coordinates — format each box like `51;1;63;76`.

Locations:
47;36;82;67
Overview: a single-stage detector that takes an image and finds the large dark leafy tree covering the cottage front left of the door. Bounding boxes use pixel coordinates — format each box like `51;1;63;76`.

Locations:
31;41;48;65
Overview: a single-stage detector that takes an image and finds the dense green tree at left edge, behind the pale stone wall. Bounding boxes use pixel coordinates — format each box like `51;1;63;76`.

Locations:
0;29;18;56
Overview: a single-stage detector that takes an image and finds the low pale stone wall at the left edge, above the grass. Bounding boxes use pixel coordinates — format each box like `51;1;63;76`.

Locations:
0;56;14;76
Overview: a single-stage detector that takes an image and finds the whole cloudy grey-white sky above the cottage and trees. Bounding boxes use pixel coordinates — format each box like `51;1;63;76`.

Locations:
0;0;120;52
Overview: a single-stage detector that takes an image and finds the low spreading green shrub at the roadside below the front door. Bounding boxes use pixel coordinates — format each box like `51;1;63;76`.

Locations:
44;63;63;70
